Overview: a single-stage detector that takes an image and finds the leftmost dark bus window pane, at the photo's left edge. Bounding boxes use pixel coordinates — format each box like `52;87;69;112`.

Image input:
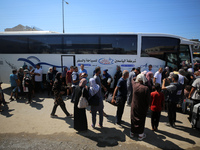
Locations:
0;36;28;53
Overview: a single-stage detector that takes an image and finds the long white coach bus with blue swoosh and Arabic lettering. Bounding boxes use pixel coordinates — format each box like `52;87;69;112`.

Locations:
0;31;199;83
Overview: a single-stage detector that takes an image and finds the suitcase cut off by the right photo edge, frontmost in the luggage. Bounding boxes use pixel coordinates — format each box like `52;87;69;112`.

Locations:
191;103;200;128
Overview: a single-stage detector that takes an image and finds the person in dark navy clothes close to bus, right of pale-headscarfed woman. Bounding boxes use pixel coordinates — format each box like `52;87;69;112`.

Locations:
101;69;113;98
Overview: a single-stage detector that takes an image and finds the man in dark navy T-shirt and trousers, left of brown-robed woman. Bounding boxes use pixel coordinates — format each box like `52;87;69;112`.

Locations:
112;70;129;127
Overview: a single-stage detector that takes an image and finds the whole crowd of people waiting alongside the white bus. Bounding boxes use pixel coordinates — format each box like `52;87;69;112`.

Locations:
0;64;200;140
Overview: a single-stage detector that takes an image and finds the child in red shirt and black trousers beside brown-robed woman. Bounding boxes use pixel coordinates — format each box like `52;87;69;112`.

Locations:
150;83;164;131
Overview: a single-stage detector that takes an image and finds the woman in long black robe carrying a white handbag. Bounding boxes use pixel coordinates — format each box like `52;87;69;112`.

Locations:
74;78;89;131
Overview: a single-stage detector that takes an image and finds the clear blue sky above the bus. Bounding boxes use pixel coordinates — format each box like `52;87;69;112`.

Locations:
0;0;200;39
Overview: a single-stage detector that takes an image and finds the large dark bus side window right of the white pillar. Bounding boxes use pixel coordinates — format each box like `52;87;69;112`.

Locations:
141;36;180;60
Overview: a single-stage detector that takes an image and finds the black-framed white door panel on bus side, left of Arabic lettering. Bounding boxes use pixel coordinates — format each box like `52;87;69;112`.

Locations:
61;55;75;71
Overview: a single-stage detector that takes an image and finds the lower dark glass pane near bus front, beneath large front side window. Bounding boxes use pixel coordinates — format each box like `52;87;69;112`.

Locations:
165;53;179;69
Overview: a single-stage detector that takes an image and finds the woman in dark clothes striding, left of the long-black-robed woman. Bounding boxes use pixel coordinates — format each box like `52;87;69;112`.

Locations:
51;72;72;117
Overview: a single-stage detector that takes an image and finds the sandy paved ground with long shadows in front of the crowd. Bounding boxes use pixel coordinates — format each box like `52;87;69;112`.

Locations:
0;84;200;150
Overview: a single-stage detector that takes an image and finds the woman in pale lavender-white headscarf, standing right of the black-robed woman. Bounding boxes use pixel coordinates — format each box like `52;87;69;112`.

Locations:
89;78;104;128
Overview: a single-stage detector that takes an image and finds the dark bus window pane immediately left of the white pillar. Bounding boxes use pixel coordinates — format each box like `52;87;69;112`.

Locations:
101;35;137;55
